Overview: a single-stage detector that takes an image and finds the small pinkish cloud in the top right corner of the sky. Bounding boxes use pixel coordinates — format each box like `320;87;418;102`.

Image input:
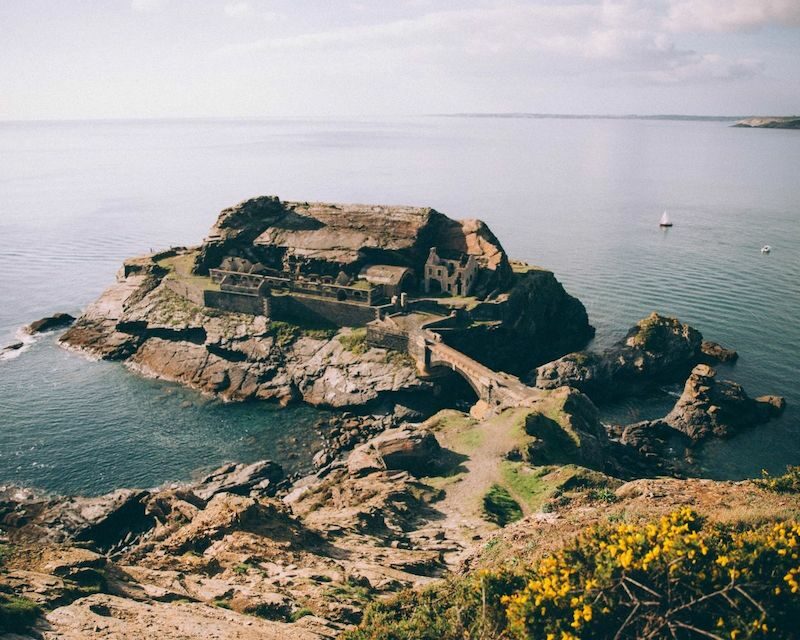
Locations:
665;0;800;32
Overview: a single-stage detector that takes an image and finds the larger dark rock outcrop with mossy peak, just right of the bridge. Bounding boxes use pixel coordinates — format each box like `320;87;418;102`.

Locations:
531;313;703;400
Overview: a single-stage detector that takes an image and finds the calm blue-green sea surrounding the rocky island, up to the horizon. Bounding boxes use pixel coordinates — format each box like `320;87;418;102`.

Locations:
0;117;800;493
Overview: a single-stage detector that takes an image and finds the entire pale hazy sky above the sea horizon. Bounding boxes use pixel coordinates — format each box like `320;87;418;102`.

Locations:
0;0;800;119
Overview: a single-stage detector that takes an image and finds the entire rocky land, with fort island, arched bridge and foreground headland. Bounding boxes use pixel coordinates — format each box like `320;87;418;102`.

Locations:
0;197;800;640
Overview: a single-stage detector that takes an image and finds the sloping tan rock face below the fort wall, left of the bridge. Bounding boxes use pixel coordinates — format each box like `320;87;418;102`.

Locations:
61;268;431;407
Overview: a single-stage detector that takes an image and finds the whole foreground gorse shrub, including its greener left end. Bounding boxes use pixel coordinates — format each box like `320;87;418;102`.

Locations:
346;508;800;640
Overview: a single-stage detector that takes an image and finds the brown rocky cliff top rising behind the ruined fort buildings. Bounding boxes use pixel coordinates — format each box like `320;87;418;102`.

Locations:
195;196;511;294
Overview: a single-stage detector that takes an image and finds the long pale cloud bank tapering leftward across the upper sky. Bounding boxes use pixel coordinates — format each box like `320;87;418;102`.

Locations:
216;0;788;90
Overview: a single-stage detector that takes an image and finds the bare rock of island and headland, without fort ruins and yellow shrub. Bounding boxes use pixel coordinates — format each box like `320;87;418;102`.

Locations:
0;199;788;640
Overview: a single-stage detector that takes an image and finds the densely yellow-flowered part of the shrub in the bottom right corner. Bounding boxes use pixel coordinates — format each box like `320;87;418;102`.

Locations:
502;508;800;640
